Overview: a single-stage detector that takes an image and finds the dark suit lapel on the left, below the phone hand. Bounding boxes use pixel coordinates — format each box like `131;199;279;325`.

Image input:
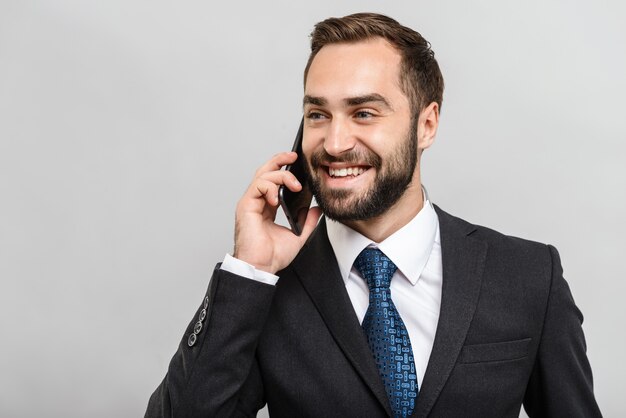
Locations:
292;219;391;415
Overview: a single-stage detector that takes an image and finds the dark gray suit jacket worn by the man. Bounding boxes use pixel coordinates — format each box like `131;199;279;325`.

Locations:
146;208;601;418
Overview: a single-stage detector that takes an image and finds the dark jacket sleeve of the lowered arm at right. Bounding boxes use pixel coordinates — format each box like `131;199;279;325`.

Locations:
524;246;602;418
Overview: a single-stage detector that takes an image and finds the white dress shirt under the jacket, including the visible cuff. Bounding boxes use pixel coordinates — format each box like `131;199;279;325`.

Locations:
221;199;442;385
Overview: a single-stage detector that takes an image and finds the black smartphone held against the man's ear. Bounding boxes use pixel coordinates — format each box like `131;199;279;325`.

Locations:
278;118;313;235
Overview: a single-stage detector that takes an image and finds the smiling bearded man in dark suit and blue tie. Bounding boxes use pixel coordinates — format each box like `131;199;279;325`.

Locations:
146;14;600;417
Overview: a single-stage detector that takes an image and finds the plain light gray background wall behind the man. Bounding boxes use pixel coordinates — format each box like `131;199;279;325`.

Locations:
0;0;626;417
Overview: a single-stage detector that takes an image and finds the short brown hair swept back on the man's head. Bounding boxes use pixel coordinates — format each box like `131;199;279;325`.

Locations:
304;13;443;114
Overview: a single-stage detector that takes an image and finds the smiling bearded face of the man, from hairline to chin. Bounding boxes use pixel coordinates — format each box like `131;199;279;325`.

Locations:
303;39;421;221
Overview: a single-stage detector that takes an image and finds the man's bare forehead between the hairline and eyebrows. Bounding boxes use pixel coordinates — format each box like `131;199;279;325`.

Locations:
305;38;404;101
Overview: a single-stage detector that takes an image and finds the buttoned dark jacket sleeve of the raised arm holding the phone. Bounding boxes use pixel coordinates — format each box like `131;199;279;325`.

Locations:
145;265;275;418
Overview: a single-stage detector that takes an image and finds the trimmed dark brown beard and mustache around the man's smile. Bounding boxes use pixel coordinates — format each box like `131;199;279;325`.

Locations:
303;118;417;222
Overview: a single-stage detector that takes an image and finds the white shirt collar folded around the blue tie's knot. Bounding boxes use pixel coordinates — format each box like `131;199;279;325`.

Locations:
326;190;439;285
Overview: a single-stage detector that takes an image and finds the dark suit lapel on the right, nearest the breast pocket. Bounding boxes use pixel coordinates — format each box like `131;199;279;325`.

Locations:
413;206;487;417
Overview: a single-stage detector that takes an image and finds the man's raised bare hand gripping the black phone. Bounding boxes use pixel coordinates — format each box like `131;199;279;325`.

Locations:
233;152;322;274
